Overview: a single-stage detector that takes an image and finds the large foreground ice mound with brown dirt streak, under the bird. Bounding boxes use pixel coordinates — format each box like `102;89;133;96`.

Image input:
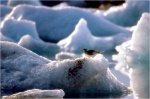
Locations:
0;41;130;97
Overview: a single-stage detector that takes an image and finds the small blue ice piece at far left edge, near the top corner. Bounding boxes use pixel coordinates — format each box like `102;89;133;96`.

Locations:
0;5;12;20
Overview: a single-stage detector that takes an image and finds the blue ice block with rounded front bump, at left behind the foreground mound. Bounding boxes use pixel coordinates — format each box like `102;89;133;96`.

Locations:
0;19;60;59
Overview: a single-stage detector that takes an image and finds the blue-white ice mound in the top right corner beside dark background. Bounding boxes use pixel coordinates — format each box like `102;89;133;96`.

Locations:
96;0;150;26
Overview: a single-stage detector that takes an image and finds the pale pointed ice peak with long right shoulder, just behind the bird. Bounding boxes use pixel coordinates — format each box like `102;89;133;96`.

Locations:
58;18;130;52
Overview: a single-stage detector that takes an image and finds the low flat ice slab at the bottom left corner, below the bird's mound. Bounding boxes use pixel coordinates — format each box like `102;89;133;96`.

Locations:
2;89;65;99
